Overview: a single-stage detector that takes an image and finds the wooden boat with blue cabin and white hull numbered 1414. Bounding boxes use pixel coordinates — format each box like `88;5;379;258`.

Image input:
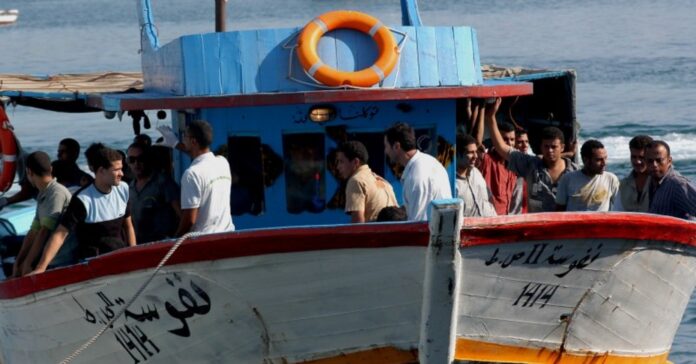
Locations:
0;0;696;363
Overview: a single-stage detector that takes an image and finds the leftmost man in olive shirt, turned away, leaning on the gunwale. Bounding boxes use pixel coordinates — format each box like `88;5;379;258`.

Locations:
12;151;76;277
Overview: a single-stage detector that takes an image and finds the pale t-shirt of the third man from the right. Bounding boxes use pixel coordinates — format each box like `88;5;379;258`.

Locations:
556;170;619;211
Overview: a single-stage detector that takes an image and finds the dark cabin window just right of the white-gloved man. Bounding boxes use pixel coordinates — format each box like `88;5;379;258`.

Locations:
227;136;265;215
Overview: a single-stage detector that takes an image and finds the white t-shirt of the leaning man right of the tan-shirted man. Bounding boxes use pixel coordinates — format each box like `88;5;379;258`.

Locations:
401;151;452;221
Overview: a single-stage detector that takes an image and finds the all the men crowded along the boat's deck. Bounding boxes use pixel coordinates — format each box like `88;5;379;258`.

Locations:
0;98;696;277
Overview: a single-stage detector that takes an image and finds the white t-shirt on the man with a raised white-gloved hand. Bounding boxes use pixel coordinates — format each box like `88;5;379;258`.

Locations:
181;152;234;233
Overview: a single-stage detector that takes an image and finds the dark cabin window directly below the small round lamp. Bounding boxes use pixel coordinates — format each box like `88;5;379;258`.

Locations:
283;133;326;214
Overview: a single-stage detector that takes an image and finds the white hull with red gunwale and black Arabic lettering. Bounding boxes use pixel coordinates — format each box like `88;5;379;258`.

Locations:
0;214;696;363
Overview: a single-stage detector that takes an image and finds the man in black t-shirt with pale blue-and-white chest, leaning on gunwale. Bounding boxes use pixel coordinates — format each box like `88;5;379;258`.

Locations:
31;143;135;274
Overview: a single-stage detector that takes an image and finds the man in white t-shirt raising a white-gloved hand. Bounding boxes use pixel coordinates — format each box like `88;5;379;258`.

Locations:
158;120;234;236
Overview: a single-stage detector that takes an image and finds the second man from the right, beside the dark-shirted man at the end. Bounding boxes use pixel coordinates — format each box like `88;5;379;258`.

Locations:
614;135;652;212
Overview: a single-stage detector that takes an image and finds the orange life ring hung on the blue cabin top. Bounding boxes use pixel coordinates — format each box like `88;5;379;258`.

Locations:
297;10;399;87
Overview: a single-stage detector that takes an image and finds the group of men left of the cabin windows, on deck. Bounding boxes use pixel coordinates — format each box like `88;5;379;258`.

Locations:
0;121;234;277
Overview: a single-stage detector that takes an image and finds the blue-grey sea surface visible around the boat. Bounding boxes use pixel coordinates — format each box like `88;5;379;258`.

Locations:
0;0;696;363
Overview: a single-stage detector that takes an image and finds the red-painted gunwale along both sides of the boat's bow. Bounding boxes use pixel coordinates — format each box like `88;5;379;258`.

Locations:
0;213;696;299
